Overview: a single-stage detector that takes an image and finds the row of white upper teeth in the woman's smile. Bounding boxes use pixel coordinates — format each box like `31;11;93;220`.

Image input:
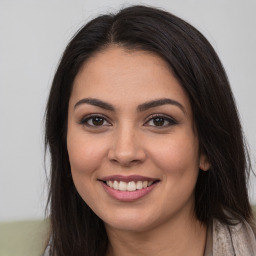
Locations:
106;180;153;191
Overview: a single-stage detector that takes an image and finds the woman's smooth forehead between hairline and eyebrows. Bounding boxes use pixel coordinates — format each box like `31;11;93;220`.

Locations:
71;46;191;112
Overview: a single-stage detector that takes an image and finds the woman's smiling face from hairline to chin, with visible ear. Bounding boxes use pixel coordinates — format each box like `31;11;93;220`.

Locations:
67;46;207;231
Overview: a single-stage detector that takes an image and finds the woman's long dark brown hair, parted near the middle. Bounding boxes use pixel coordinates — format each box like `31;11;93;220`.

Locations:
45;6;253;256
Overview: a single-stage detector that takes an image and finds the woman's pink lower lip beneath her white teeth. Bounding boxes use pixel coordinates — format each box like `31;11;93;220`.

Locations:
102;182;158;202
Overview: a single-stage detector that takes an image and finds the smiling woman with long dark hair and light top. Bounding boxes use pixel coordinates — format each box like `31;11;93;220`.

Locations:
45;6;256;256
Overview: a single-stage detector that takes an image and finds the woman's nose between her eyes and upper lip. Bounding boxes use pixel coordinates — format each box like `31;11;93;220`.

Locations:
108;124;146;167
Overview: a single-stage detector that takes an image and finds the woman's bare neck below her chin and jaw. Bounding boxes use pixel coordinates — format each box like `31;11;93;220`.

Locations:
106;211;206;256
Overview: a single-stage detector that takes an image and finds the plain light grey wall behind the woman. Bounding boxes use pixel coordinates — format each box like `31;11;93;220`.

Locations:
0;0;256;221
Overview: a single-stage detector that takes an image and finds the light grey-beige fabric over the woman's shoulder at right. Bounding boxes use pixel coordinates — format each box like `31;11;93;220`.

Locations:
212;219;256;256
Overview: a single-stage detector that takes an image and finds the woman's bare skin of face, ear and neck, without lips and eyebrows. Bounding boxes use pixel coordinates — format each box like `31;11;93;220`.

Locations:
67;46;209;256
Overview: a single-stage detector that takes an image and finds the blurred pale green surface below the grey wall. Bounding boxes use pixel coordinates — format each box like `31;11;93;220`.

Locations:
0;206;256;256
